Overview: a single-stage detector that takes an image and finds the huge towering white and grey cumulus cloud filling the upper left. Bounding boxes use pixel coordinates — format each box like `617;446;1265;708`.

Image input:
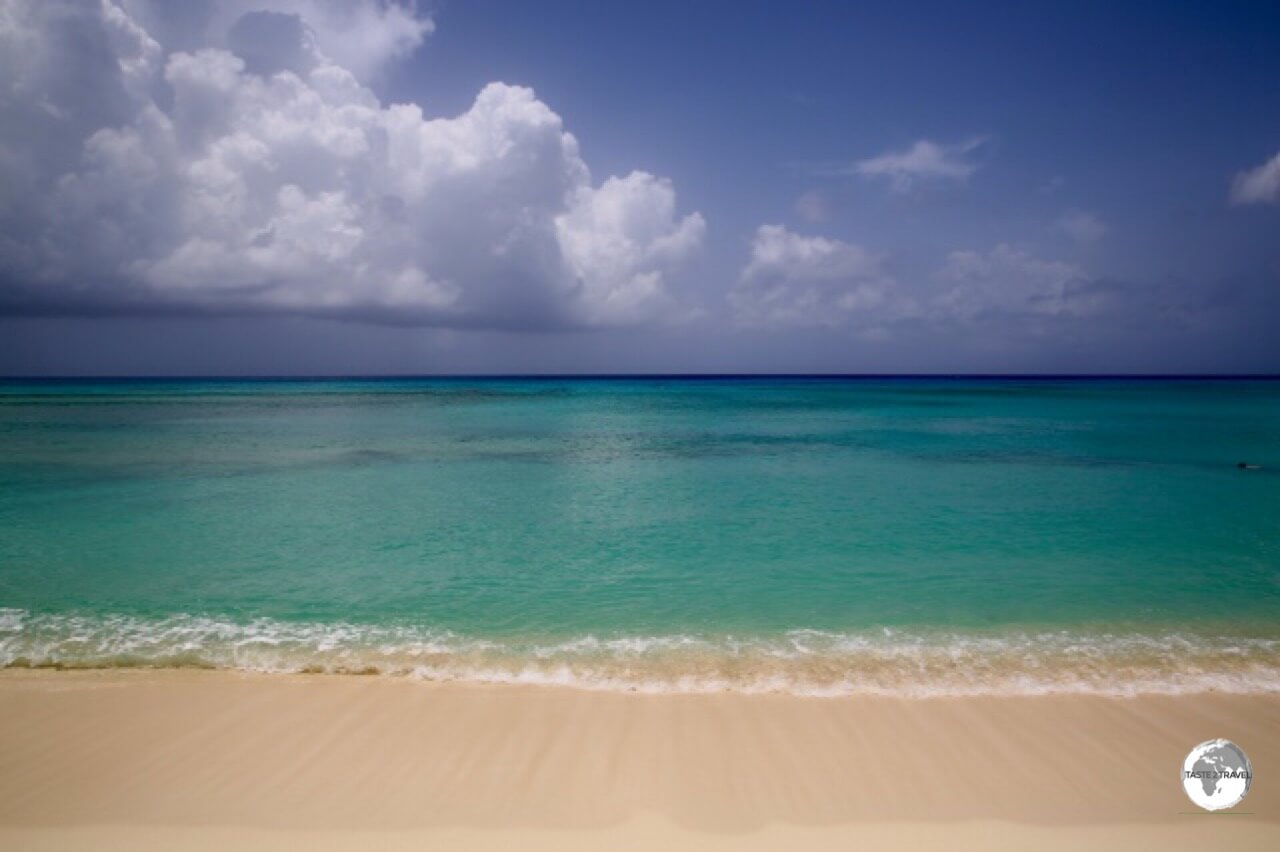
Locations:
0;0;705;329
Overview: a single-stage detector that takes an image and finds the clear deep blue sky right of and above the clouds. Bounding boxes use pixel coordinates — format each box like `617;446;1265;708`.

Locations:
401;1;1280;276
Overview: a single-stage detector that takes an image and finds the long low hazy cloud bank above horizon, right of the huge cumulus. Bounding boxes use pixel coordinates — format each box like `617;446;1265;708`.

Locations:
728;225;1249;348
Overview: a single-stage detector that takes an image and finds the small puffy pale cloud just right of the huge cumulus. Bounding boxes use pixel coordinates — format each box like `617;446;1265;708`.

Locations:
730;225;901;326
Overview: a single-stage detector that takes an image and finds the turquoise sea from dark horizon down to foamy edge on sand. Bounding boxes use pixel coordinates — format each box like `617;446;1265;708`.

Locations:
0;379;1280;693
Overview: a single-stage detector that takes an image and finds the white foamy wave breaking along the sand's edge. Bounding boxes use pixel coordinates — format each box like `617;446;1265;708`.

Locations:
0;609;1280;697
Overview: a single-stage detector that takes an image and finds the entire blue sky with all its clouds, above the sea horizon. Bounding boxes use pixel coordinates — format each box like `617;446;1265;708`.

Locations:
0;0;1280;376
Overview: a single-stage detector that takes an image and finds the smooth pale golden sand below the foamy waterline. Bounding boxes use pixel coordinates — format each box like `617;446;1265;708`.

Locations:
0;670;1280;849
